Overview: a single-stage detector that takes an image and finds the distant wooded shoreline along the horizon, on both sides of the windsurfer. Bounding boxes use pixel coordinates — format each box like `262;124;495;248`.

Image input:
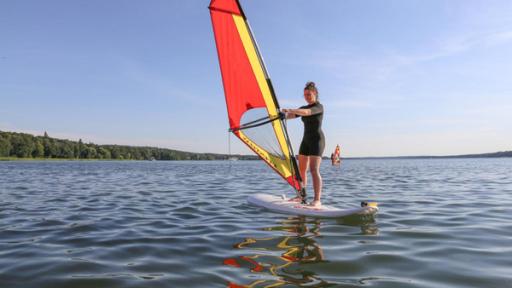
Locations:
0;131;512;161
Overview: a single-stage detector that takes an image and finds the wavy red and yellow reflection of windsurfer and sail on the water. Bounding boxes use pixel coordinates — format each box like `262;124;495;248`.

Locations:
224;216;378;288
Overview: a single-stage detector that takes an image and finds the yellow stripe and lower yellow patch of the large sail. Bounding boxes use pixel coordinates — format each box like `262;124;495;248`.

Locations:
233;15;292;177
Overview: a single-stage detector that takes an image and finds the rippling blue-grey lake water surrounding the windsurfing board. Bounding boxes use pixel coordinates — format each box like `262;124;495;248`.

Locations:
0;159;512;288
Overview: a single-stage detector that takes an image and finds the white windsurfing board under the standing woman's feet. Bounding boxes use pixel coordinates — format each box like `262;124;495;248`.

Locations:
247;193;379;218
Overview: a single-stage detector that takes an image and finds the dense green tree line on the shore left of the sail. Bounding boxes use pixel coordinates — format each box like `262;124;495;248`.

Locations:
0;131;254;160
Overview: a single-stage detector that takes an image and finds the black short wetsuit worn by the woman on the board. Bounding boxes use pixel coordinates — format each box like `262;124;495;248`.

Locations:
299;102;325;156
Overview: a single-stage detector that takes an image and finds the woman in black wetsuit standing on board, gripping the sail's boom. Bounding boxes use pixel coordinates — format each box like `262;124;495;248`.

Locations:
282;82;325;208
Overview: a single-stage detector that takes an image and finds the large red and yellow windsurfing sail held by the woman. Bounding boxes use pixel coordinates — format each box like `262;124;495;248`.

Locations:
209;0;301;191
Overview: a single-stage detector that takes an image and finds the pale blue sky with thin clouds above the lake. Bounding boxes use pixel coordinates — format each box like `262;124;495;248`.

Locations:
0;0;512;157
